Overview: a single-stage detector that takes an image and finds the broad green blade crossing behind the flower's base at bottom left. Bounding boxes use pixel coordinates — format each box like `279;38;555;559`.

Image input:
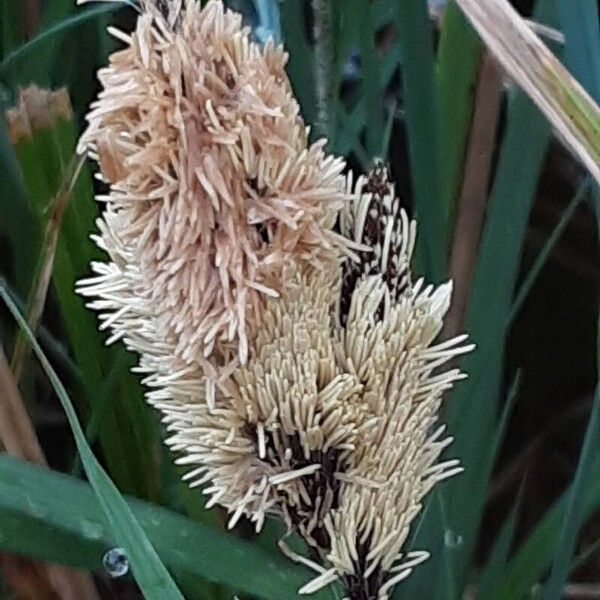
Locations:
0;455;330;600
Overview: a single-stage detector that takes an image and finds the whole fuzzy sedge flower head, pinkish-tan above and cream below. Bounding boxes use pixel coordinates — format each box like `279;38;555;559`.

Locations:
80;0;472;600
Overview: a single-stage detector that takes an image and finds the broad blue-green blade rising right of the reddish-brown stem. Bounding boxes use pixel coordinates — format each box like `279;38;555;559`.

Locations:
418;0;552;597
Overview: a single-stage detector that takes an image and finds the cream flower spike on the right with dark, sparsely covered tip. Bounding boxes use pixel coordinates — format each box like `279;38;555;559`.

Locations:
304;165;473;600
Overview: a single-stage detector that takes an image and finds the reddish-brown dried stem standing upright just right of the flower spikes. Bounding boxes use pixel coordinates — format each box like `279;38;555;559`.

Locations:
444;53;502;338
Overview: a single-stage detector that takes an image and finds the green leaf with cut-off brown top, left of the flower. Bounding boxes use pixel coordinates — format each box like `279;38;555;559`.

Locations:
7;87;158;499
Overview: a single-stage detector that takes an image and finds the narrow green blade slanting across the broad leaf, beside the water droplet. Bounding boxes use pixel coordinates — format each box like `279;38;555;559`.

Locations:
0;284;183;600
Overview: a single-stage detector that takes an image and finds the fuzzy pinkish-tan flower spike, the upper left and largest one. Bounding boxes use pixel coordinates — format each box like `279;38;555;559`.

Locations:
79;0;347;380
